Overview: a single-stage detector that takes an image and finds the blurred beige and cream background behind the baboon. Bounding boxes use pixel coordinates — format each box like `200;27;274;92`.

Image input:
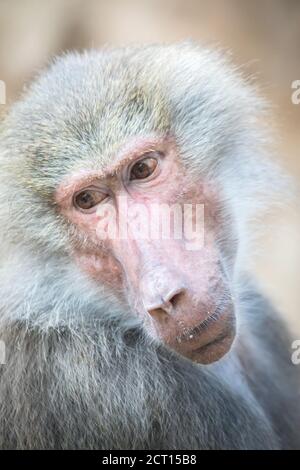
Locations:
0;0;300;339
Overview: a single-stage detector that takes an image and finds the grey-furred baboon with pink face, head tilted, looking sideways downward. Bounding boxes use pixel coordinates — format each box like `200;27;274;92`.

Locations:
0;43;300;449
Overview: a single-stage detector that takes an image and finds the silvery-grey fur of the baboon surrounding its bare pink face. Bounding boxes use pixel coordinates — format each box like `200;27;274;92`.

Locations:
0;44;300;449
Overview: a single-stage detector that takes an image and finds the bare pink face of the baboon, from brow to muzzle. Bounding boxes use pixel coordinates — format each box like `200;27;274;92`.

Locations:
56;138;235;364
